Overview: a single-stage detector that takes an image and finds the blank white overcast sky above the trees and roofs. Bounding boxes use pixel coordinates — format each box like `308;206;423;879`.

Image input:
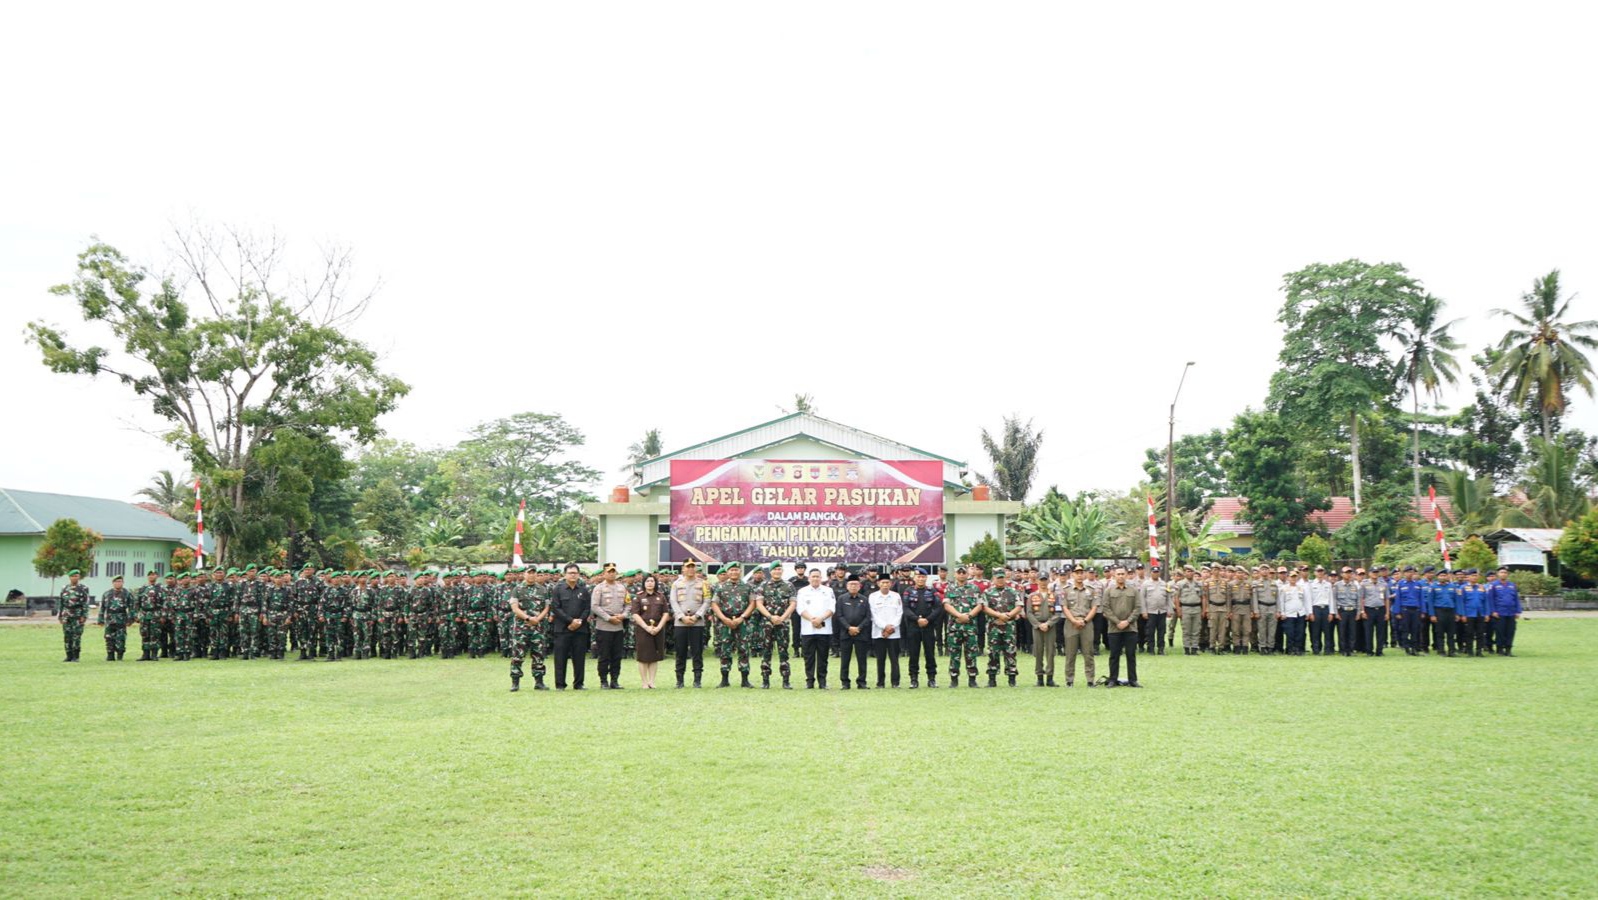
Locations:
0;0;1598;499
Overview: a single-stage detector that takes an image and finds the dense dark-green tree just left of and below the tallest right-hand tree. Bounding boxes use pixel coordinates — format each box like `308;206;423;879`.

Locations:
1222;411;1331;558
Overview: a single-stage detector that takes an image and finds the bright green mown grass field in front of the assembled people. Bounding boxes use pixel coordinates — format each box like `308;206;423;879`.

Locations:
0;619;1598;897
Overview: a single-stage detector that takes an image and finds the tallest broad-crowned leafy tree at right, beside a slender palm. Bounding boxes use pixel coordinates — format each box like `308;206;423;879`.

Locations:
1269;259;1425;508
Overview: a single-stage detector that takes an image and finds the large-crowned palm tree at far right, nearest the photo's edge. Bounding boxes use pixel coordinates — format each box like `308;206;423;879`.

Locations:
1491;269;1598;441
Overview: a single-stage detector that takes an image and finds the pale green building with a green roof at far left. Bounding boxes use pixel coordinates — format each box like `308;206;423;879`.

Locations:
0;488;195;596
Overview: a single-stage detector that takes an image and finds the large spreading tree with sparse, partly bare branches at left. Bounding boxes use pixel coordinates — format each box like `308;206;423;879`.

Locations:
29;227;409;561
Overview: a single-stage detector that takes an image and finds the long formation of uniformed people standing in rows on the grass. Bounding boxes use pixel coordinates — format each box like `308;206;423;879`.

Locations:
58;561;1521;691
